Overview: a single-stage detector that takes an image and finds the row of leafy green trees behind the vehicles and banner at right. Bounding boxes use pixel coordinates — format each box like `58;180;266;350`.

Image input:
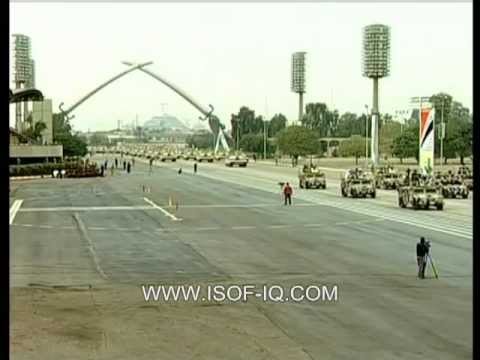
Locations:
268;93;473;164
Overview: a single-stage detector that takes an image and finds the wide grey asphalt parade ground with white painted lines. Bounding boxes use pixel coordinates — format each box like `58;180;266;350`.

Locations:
10;158;472;360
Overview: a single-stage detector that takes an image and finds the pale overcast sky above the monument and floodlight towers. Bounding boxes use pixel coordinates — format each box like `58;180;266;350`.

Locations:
10;3;473;130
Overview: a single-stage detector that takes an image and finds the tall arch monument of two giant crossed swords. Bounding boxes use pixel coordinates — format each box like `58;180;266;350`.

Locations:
58;61;230;153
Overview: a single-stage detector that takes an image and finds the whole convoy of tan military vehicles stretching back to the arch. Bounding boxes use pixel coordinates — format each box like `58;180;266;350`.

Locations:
88;145;473;210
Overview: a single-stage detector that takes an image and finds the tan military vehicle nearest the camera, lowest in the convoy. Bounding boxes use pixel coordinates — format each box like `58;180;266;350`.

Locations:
398;184;444;210
